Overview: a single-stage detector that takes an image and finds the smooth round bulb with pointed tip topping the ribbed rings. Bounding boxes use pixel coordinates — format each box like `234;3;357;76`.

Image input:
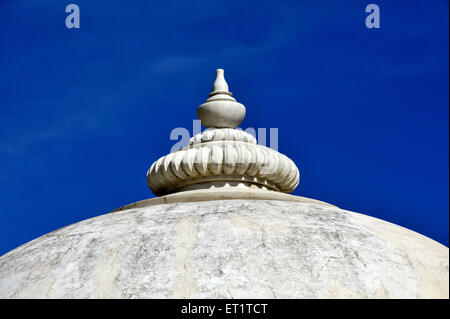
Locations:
197;69;245;128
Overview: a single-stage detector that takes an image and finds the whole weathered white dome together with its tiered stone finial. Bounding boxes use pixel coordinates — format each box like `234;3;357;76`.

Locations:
0;69;449;298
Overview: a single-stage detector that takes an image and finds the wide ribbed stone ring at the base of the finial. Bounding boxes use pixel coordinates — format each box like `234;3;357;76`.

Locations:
147;132;299;196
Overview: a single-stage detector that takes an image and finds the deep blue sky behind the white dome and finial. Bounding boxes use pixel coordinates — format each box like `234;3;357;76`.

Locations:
0;0;449;254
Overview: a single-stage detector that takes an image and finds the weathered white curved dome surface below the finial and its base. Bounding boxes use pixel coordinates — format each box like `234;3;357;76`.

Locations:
0;200;449;298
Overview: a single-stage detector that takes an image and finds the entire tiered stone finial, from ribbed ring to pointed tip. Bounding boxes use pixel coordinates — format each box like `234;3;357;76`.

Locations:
147;69;299;196
